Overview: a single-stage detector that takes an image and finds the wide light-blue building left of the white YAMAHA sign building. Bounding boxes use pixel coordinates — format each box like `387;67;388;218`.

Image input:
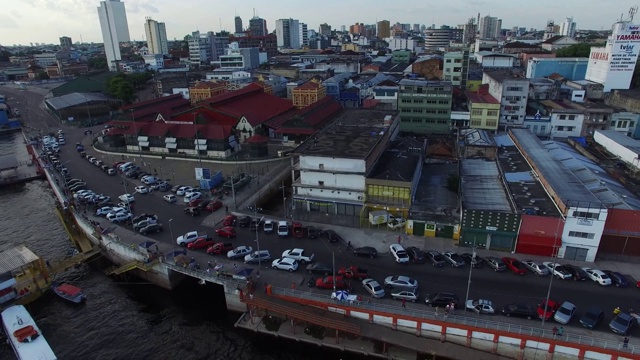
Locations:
527;57;589;80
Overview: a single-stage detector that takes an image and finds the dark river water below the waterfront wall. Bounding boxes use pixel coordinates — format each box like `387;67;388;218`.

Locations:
0;133;365;360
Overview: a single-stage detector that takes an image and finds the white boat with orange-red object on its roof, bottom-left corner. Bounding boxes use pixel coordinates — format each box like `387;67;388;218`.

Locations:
2;305;57;360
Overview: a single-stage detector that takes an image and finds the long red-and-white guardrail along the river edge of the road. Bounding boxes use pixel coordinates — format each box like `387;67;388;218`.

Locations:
271;287;640;354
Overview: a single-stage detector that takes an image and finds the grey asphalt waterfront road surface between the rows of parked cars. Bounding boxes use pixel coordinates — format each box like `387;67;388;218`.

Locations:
6;84;640;339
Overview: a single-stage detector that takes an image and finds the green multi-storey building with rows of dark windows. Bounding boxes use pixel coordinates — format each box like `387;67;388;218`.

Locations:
398;79;453;134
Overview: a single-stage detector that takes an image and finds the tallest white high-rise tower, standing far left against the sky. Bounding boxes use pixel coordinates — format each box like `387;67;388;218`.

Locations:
98;0;130;71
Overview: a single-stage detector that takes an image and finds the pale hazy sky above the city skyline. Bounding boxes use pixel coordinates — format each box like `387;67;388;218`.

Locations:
0;0;640;46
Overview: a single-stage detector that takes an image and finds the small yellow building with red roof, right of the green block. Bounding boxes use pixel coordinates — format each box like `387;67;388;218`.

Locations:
466;85;500;131
